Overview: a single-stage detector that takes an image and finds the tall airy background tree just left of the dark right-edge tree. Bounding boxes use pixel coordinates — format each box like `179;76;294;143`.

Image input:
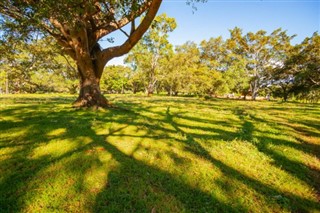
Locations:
230;28;294;100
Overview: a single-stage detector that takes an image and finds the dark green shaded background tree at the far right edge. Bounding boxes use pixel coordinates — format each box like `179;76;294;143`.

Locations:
274;33;320;101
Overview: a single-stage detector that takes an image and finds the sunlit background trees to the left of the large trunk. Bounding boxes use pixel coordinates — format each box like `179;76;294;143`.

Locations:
0;38;78;93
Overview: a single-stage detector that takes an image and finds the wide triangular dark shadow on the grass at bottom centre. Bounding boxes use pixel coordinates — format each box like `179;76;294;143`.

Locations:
91;137;239;212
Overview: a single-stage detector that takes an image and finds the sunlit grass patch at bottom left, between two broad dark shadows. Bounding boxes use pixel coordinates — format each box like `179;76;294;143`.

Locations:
24;147;119;212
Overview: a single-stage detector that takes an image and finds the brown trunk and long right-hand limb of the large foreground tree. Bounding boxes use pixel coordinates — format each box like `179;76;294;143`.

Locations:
73;0;161;107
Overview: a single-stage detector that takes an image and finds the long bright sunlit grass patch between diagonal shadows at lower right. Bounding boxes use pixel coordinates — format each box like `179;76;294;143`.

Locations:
212;141;316;202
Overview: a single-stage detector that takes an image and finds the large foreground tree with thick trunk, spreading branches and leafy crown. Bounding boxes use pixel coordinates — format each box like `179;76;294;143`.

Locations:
0;0;162;107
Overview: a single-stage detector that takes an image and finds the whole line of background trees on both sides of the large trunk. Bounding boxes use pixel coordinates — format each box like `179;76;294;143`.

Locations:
0;14;320;101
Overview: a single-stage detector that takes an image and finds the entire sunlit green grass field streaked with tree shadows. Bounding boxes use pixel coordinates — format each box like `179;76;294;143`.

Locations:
0;95;320;213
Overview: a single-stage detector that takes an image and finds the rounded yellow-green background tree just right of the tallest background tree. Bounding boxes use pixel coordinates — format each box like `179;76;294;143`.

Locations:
163;42;223;96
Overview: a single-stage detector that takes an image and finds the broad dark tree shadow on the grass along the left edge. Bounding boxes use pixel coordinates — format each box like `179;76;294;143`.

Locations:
0;106;99;212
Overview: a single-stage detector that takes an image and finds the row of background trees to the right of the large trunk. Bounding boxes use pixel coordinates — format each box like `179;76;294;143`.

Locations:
102;14;320;101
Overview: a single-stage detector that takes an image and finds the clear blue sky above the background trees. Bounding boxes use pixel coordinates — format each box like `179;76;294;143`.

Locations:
109;0;320;64
